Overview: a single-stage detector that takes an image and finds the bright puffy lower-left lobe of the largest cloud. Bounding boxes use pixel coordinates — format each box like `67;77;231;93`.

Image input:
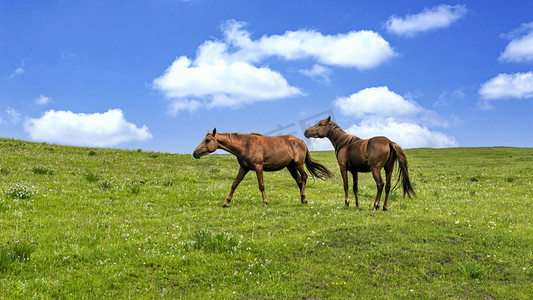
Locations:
154;56;303;112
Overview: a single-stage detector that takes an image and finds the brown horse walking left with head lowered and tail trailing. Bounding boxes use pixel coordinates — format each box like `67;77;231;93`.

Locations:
193;128;333;207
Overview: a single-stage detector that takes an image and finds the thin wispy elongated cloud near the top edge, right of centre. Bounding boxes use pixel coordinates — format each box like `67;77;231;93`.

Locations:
387;4;467;36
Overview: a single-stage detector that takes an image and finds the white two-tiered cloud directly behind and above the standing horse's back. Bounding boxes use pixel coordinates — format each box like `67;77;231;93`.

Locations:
333;87;457;148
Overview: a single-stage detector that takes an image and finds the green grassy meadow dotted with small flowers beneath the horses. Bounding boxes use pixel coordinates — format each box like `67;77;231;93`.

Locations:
0;139;533;299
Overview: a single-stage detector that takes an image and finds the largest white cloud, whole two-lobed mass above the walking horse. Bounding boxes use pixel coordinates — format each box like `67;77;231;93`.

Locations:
153;20;396;113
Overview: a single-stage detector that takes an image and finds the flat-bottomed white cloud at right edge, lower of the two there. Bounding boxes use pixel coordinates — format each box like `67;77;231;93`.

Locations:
479;72;533;109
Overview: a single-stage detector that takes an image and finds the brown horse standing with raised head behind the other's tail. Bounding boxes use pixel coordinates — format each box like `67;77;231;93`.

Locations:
304;117;416;210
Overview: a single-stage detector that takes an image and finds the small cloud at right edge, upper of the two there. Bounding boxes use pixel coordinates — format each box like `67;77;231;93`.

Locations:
498;22;533;62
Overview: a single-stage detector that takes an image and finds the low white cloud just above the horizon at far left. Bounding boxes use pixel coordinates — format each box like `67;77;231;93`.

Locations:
24;109;152;147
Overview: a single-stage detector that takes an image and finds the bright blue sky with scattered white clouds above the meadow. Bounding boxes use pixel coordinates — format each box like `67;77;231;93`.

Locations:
0;0;533;153
